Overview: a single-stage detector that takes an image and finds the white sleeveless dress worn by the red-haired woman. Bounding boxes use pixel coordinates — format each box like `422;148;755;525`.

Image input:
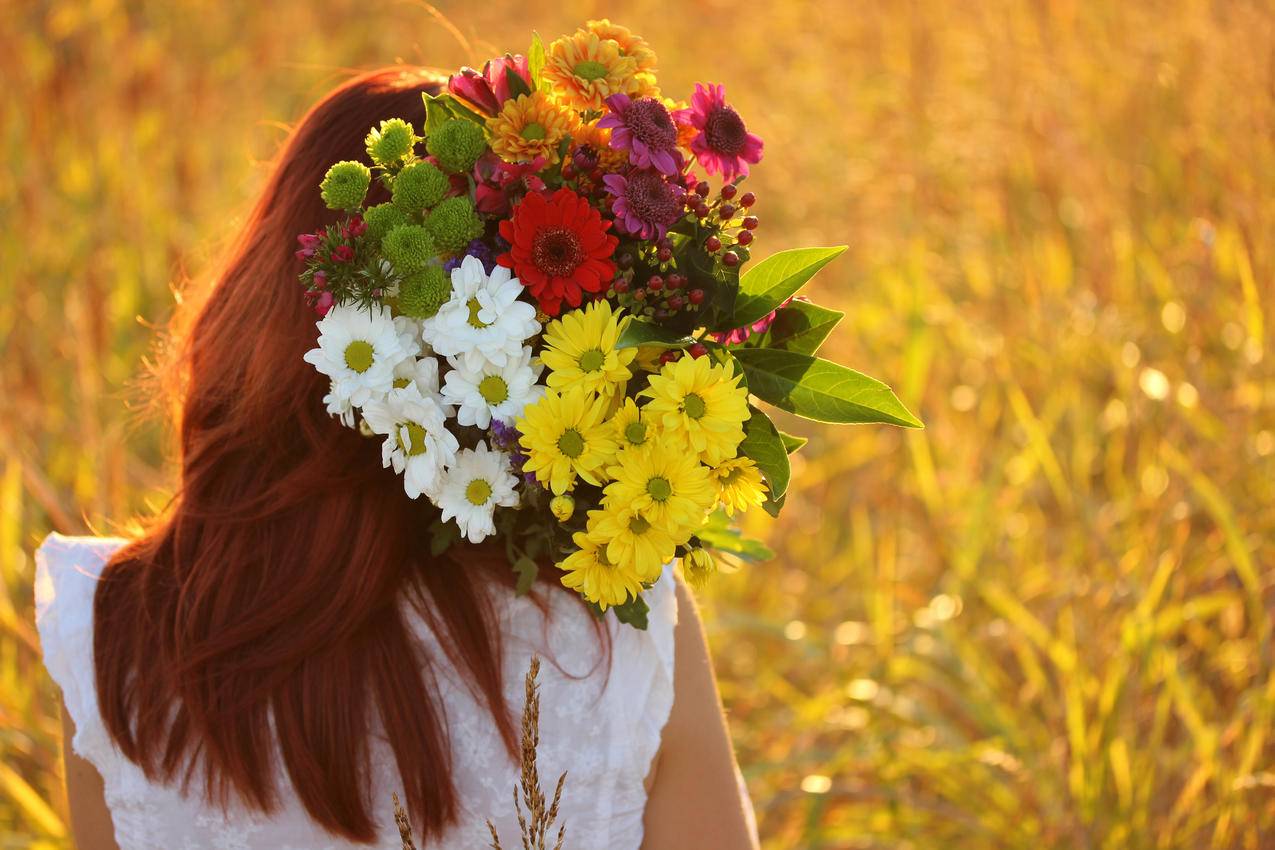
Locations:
36;534;677;850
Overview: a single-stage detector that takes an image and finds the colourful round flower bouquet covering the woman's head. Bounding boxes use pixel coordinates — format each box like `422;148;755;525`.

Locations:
297;20;921;628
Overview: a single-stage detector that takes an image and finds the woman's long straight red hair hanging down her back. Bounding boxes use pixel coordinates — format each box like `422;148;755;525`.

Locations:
93;69;576;841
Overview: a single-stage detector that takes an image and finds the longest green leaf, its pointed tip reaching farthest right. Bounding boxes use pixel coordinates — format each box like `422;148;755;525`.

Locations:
734;348;924;428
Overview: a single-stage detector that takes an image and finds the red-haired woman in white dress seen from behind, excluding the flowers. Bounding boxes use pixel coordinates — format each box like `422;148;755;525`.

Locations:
37;69;755;850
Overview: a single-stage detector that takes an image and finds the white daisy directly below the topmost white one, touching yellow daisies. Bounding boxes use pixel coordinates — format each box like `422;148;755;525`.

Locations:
442;345;544;428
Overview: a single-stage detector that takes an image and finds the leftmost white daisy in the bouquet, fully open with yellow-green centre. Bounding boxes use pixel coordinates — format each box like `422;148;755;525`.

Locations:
305;305;414;422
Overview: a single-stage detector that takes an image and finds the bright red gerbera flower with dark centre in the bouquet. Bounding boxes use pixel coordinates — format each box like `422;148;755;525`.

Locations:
496;189;620;316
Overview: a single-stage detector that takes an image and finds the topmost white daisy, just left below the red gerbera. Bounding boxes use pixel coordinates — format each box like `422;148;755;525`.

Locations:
422;256;541;370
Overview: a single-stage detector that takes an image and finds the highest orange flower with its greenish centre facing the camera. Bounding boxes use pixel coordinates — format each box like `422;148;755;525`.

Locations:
543;31;643;112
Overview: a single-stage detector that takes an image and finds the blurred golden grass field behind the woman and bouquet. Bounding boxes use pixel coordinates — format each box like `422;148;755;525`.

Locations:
0;0;1275;850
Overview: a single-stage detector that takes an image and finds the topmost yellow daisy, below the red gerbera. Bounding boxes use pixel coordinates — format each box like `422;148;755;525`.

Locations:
541;301;638;398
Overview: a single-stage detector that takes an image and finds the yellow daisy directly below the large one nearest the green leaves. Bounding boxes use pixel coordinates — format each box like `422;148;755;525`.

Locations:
603;437;717;543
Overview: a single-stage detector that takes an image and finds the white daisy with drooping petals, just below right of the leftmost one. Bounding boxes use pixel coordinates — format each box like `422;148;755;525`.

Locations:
363;384;460;498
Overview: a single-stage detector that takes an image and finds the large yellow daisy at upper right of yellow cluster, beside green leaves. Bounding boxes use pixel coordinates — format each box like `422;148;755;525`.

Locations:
641;356;748;466
